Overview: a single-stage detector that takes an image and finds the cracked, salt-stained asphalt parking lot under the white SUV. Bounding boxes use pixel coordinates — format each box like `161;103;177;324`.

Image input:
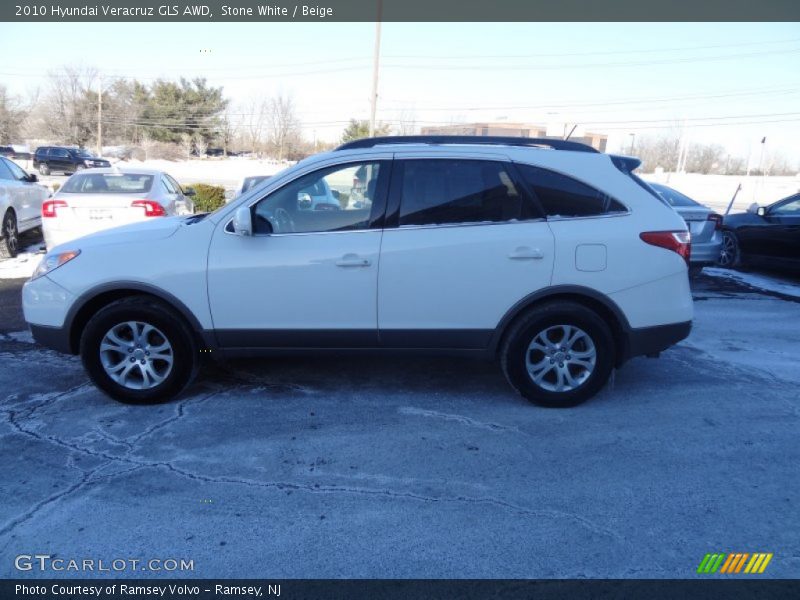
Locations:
0;277;800;578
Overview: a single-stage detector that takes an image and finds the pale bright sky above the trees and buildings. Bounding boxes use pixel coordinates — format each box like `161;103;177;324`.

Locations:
0;23;800;161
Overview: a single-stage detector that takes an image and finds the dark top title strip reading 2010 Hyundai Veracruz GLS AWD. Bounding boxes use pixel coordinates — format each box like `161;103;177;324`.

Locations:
6;0;800;22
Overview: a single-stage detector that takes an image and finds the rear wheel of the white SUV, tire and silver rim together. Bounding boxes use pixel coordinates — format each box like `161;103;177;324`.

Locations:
500;301;614;408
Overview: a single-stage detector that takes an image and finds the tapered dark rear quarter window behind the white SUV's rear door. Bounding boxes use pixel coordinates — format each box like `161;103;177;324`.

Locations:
517;164;627;217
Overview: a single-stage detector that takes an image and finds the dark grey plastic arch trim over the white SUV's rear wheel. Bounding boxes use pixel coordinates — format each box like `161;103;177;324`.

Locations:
489;285;631;366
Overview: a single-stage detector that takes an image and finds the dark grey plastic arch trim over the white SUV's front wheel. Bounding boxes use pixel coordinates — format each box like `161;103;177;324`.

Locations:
65;282;214;354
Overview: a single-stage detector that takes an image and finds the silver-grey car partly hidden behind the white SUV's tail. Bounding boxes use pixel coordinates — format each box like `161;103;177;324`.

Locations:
649;183;722;275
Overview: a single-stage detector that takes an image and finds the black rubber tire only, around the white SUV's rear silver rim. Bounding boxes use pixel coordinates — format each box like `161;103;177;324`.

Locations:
500;301;615;408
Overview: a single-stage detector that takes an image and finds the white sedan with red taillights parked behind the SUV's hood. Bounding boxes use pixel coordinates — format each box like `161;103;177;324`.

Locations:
42;168;194;248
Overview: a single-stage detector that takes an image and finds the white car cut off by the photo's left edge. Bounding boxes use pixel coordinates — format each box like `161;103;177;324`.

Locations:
0;156;50;258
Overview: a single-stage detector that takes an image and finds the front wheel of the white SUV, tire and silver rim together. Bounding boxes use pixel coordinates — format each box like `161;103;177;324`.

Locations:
80;296;198;404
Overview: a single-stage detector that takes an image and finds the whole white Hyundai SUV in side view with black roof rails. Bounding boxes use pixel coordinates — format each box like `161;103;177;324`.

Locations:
23;136;692;406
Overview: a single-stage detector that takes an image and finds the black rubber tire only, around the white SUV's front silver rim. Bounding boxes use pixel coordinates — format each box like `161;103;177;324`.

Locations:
80;296;199;404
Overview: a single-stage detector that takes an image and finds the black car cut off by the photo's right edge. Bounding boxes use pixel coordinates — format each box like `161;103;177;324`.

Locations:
719;194;800;272
